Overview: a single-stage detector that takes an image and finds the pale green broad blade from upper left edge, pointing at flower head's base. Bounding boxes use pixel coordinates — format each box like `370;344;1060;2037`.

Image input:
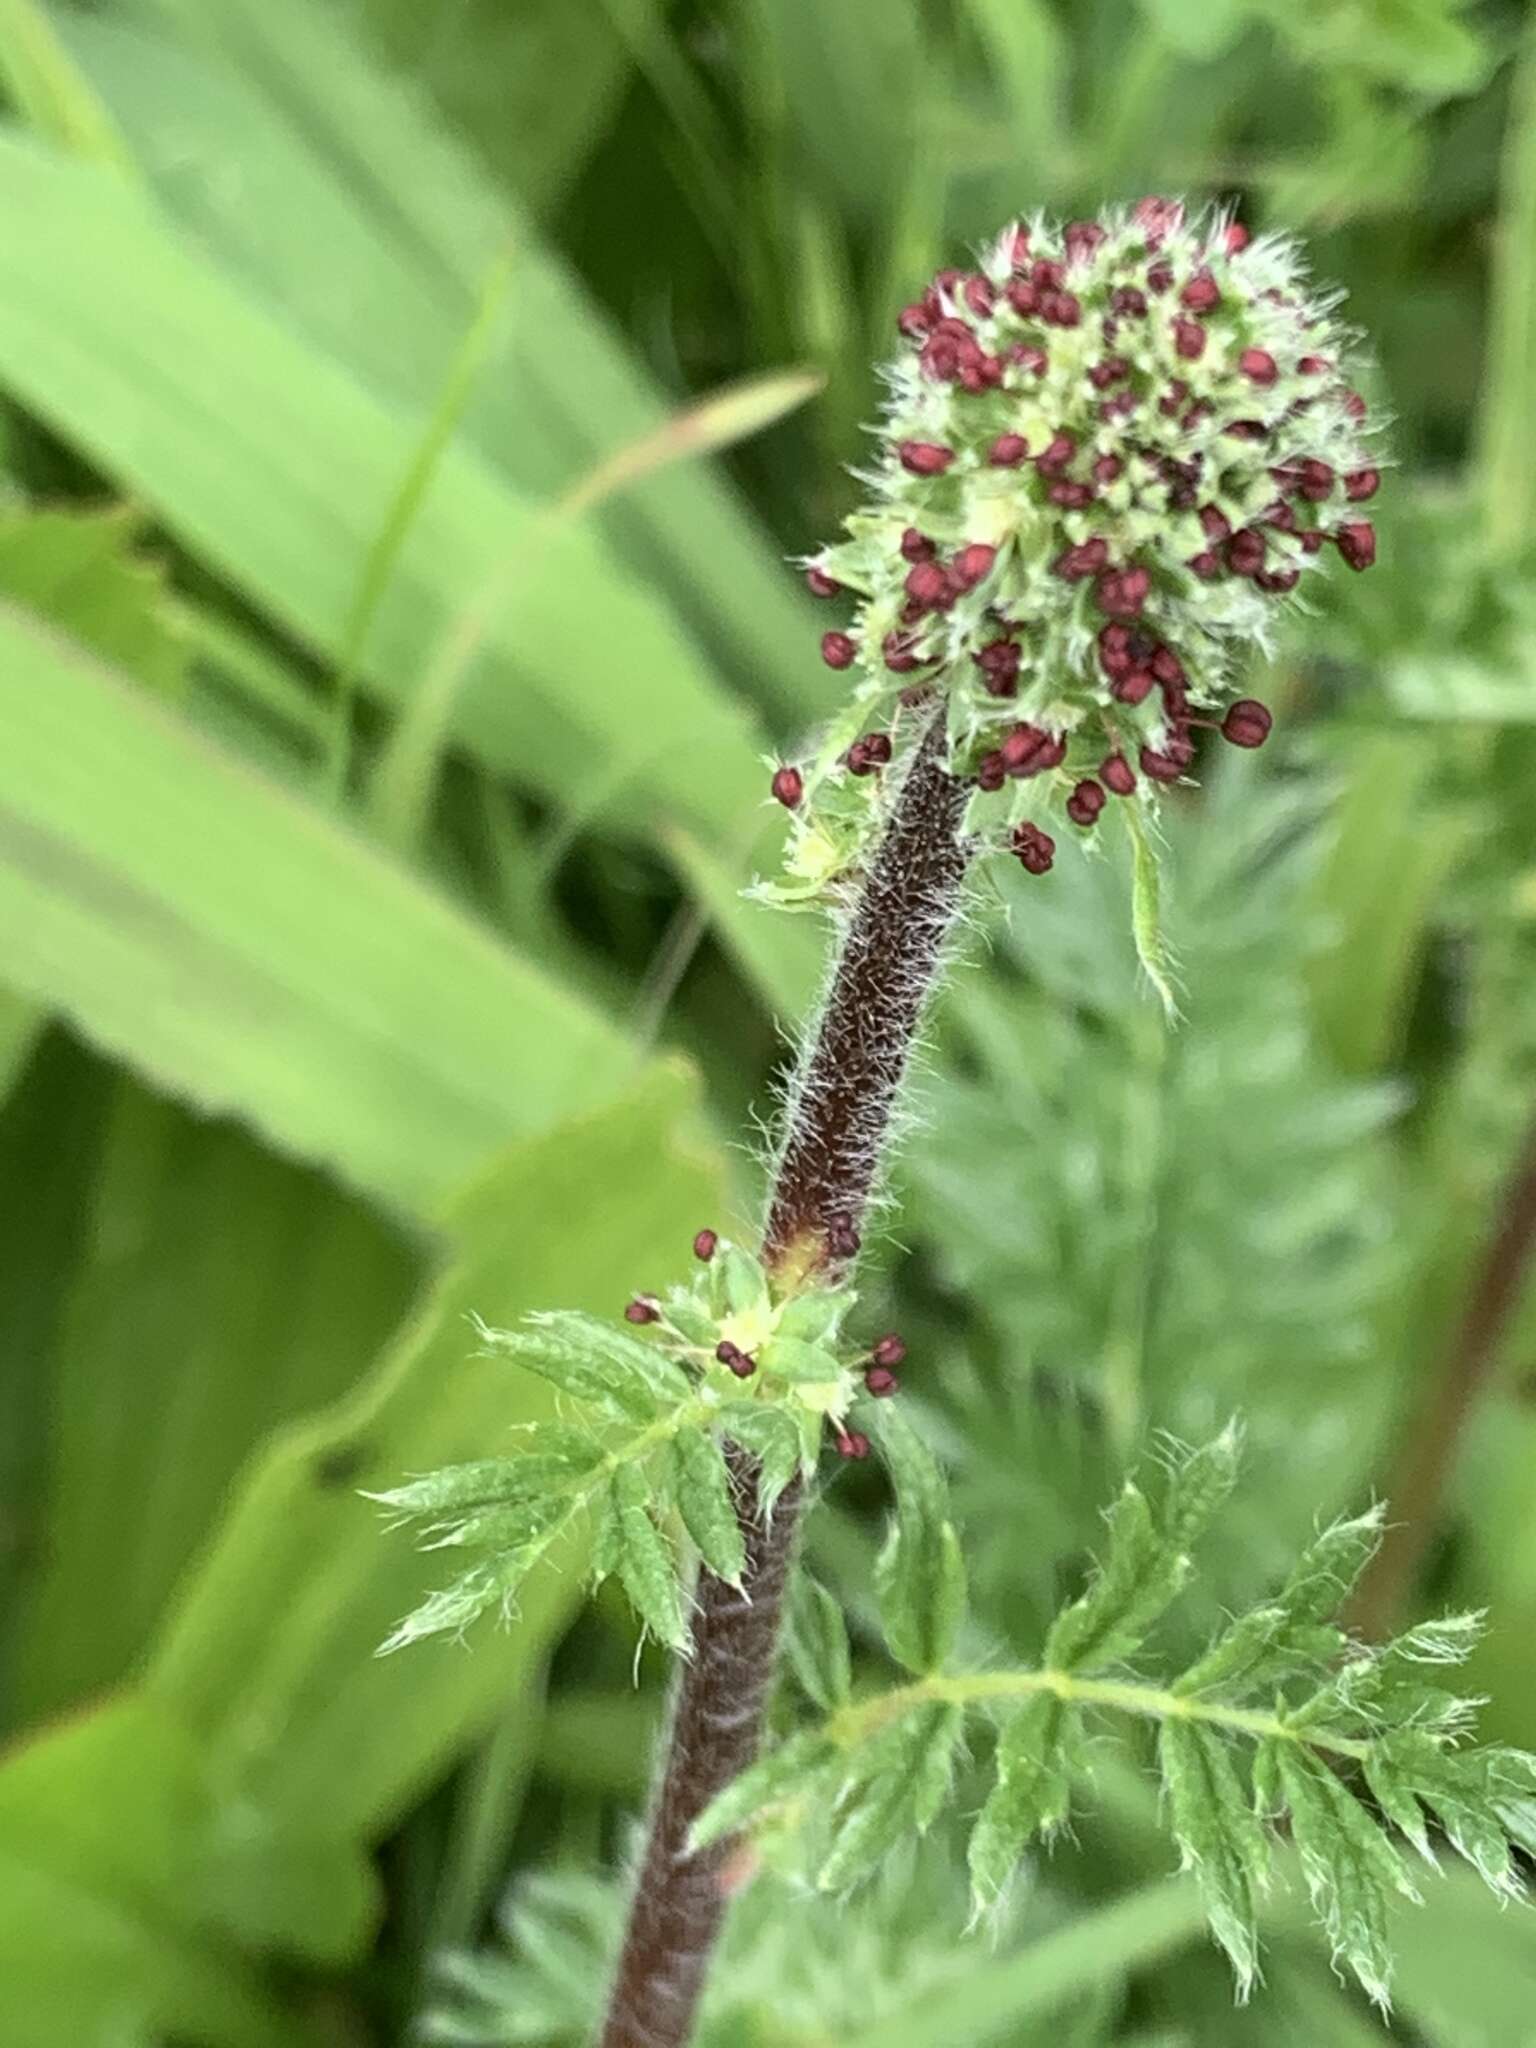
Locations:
0;139;762;847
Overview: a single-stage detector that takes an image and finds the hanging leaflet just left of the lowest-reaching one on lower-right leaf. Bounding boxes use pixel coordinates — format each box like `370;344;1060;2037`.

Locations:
1157;1720;1270;1999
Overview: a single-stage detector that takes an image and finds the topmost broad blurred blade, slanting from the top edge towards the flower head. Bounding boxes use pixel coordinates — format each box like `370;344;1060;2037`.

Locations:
85;0;821;719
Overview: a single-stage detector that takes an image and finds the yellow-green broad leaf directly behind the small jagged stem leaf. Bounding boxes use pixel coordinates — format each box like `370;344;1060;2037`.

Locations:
150;1069;721;1837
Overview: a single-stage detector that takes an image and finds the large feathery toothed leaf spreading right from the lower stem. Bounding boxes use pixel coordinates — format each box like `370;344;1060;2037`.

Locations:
694;1415;1536;2003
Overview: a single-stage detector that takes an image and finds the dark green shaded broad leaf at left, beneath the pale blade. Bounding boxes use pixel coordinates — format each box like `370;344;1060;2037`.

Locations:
14;1077;420;1718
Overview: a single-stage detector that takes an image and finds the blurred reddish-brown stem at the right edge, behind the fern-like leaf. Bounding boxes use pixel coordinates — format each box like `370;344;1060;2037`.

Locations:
1350;1120;1536;1638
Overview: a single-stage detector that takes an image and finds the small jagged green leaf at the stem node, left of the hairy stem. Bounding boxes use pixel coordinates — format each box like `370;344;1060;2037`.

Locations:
369;1241;858;1655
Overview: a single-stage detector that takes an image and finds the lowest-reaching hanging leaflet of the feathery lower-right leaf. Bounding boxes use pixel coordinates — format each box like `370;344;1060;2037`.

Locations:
1266;1741;1417;2007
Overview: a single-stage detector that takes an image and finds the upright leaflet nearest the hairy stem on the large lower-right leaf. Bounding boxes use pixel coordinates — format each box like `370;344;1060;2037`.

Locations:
874;1403;965;1675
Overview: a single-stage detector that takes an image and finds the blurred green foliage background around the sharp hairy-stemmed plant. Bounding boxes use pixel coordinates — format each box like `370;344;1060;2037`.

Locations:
0;0;1536;2048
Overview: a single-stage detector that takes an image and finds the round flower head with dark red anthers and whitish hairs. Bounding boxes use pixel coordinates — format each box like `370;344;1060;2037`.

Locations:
776;199;1378;899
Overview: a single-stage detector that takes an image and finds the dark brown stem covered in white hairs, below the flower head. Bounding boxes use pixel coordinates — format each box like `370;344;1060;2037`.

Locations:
600;709;969;2048
